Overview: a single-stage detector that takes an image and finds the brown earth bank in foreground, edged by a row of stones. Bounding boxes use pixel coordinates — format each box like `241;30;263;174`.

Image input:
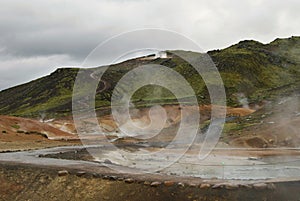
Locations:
0;164;300;201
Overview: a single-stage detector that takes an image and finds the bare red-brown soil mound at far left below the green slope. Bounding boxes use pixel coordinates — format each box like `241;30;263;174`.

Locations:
0;116;79;151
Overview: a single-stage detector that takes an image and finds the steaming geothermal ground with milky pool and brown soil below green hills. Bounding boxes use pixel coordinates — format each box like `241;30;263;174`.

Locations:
0;105;300;200
